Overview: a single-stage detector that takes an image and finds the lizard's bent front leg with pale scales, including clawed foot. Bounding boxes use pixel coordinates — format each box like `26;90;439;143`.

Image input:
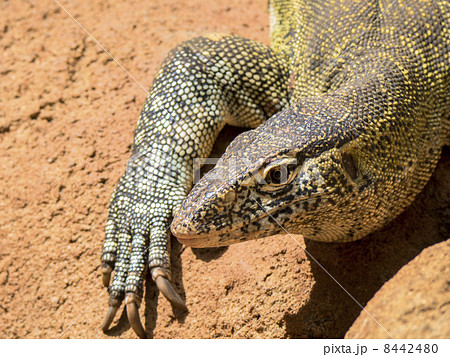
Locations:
101;34;289;337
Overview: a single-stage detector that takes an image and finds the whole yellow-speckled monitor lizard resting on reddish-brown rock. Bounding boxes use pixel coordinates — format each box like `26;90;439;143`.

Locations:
102;0;450;337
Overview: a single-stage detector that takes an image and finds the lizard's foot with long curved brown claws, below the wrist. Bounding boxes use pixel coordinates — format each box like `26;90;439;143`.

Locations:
102;172;187;338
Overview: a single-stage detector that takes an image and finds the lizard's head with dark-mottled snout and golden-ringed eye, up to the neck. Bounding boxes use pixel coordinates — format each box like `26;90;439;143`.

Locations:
171;98;388;247
